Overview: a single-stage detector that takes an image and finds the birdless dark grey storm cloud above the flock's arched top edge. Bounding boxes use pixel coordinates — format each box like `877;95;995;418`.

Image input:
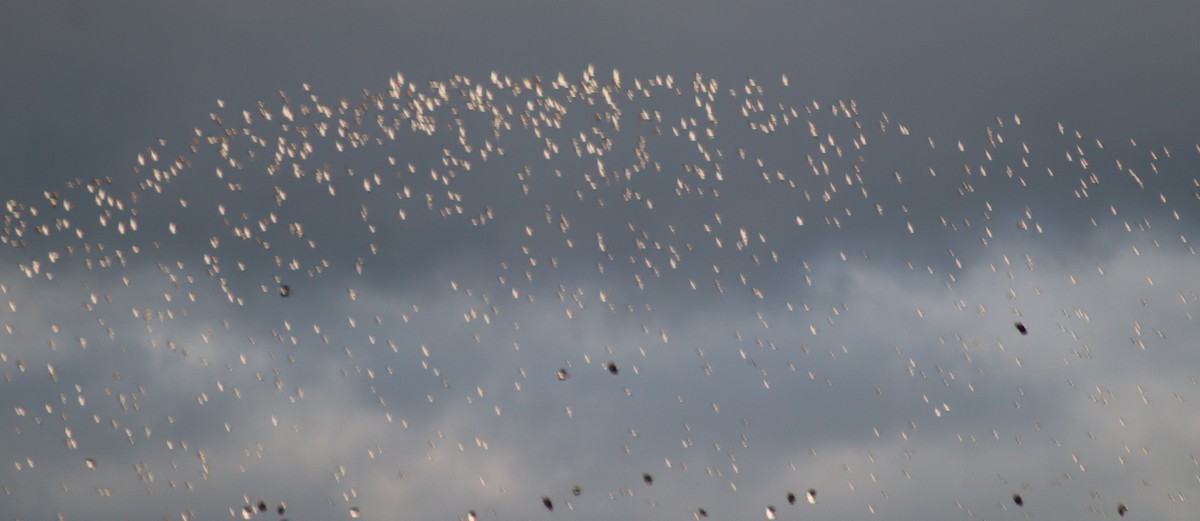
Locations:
2;2;1200;202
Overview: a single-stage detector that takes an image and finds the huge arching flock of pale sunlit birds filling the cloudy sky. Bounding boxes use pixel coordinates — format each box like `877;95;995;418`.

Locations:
0;67;1200;521
